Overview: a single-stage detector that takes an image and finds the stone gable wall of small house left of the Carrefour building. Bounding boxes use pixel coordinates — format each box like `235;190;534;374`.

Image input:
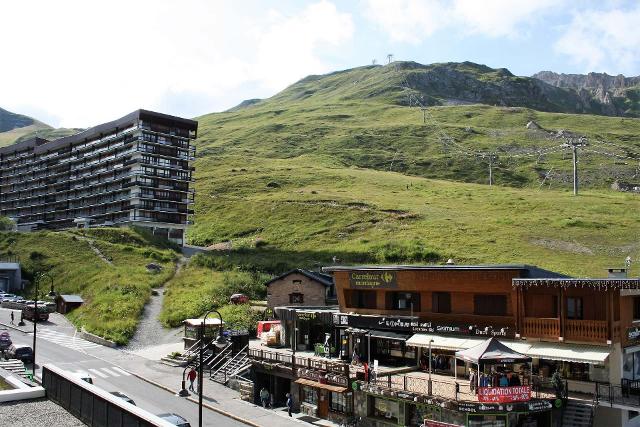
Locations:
267;273;327;309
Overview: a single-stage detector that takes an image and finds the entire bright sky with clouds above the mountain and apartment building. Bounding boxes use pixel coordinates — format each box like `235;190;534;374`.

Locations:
0;0;640;127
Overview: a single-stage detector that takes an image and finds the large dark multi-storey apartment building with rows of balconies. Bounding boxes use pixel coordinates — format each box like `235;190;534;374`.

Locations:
0;110;198;244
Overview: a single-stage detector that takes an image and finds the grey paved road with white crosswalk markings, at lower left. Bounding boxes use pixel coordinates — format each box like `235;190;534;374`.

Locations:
0;309;245;427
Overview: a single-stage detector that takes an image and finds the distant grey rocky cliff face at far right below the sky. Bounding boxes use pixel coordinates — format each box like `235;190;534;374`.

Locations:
532;71;640;117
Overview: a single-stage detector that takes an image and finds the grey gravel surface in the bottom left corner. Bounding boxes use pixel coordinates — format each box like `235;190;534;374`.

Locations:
0;399;84;427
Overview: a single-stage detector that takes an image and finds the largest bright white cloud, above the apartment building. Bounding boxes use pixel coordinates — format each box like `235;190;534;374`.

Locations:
0;0;354;126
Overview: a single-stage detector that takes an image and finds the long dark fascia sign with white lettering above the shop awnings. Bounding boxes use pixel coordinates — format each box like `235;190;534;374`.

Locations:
333;313;514;338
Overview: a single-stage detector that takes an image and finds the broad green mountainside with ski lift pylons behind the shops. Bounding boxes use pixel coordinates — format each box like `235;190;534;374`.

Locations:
189;64;640;276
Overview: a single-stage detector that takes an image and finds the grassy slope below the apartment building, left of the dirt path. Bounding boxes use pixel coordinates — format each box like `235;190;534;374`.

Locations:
0;228;176;344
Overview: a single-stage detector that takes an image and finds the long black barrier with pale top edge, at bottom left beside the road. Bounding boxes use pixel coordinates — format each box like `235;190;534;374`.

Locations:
42;365;172;427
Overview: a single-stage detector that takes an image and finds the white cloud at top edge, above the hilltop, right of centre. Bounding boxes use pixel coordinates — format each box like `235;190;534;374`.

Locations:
366;0;559;44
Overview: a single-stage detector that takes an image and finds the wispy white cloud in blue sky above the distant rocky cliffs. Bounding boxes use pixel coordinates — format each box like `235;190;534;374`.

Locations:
554;7;640;74
